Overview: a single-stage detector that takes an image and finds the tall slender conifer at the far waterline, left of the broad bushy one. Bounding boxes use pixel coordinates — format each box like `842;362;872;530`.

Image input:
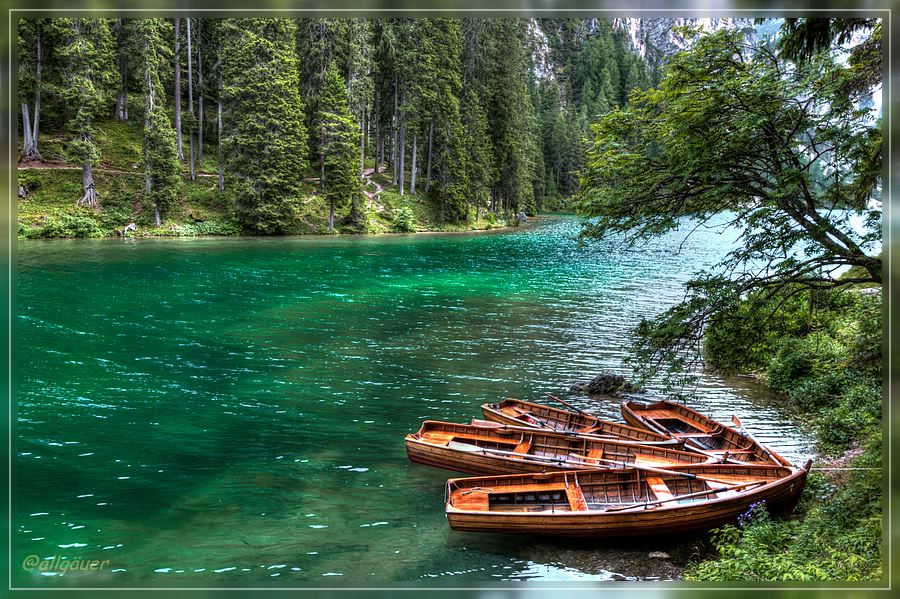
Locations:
136;19;181;226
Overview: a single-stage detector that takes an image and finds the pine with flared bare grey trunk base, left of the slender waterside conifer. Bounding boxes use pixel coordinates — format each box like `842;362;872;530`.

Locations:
53;18;116;208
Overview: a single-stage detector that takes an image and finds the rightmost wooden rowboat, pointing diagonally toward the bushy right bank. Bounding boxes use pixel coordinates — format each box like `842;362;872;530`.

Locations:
621;401;791;467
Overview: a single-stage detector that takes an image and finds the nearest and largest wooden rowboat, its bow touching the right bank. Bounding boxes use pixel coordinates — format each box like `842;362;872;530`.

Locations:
445;462;811;538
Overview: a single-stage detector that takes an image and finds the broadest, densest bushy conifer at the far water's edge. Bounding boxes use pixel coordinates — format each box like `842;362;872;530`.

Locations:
221;19;306;233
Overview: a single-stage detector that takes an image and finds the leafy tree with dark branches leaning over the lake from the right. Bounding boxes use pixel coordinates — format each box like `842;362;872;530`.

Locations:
576;25;881;384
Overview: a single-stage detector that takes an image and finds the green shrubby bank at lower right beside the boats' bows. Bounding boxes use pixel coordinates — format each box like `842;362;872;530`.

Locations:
685;289;883;581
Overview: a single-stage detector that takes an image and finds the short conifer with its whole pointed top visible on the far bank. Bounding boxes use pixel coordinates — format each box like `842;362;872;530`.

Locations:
316;64;365;231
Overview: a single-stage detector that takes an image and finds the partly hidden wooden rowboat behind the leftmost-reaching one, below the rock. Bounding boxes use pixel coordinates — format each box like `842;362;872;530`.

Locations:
481;397;678;444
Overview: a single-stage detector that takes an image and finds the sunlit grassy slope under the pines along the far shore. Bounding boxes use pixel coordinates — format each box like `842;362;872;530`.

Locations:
17;120;513;239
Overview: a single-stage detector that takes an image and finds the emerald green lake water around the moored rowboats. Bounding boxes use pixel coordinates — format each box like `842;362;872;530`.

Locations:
12;216;812;586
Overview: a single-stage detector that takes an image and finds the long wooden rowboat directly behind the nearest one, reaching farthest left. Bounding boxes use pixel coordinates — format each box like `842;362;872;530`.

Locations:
406;420;711;474
